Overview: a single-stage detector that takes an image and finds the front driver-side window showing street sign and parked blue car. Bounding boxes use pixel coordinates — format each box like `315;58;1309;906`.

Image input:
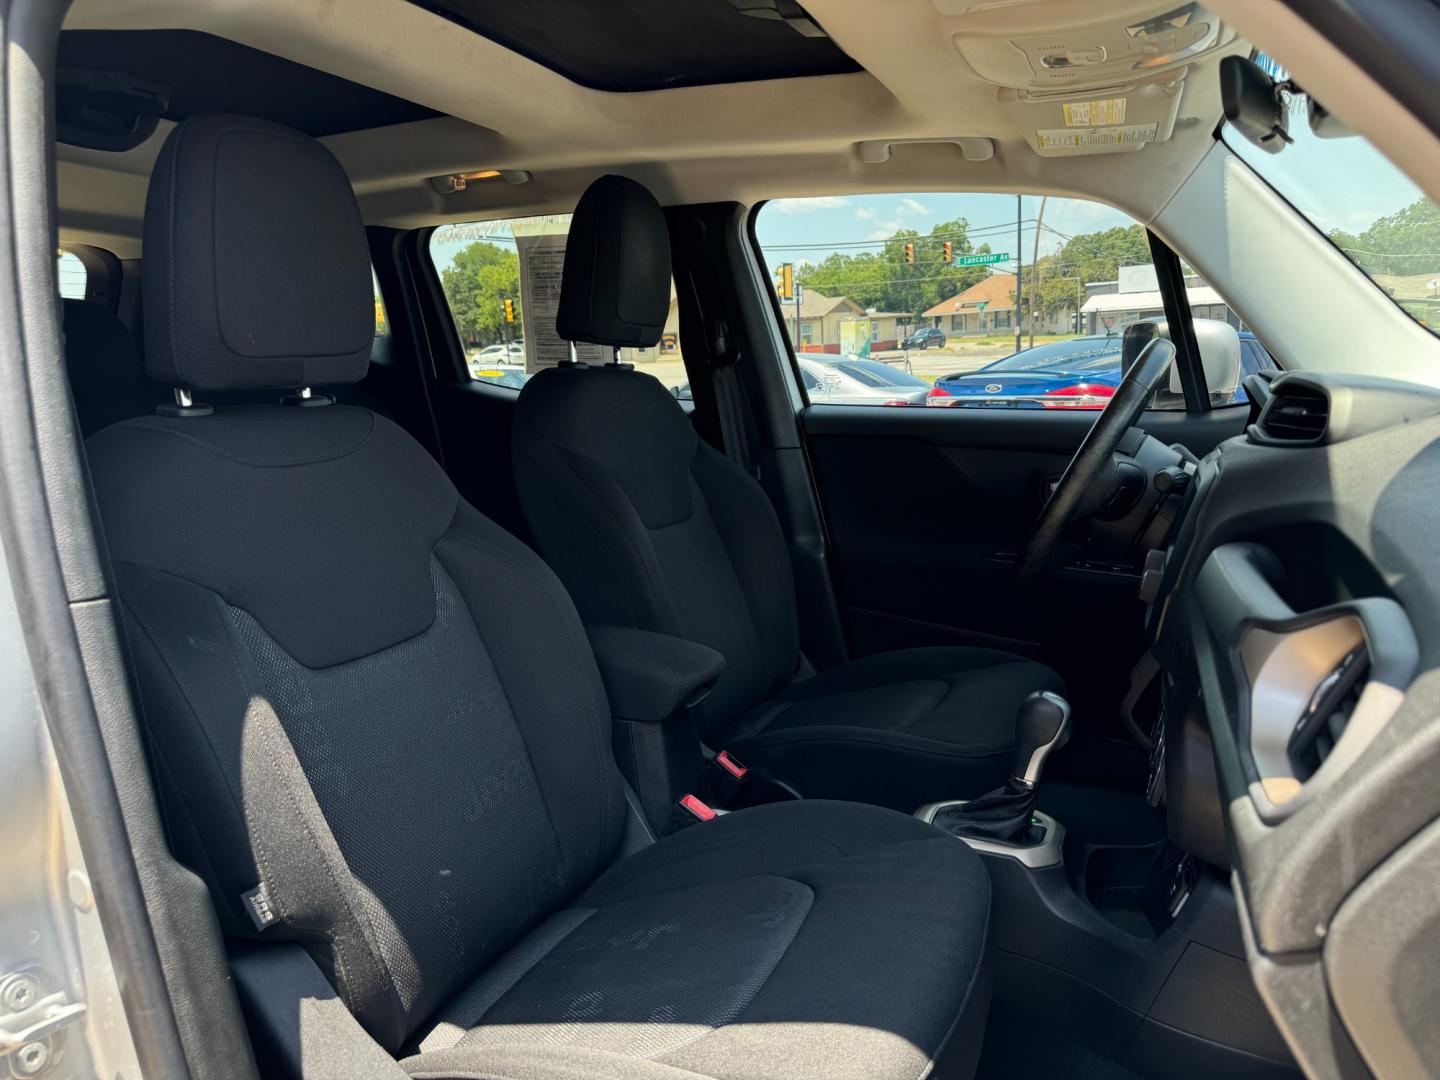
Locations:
756;193;1263;409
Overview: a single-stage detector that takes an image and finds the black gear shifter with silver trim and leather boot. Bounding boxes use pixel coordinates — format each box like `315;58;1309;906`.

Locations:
933;690;1070;844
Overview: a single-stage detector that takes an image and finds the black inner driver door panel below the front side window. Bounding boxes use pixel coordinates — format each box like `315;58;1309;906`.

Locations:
802;406;1246;779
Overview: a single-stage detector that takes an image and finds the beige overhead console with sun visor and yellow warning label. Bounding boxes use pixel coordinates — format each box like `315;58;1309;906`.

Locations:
932;0;1248;157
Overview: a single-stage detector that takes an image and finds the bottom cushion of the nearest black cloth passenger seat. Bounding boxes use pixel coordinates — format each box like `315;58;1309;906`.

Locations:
406;801;989;1080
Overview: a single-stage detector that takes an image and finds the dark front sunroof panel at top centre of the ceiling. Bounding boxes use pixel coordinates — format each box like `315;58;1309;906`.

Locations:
410;0;860;92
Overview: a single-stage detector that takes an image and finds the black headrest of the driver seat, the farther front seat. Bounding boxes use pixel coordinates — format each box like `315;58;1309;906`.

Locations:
554;176;670;348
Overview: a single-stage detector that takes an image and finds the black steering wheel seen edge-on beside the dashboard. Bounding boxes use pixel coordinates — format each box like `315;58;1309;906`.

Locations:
1015;337;1175;585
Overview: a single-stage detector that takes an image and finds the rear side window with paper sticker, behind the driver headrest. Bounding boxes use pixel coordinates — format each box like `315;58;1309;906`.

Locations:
431;213;688;400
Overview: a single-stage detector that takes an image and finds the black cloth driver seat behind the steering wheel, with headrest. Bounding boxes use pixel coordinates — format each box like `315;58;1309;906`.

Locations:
513;176;1064;812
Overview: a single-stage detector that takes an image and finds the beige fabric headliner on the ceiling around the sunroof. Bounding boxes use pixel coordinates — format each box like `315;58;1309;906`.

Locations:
58;0;1440;256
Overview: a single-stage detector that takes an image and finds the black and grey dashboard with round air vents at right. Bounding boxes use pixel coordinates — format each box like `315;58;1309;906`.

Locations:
1148;372;1440;1076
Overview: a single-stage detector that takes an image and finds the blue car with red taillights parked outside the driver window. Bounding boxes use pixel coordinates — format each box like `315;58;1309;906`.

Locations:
926;330;1276;409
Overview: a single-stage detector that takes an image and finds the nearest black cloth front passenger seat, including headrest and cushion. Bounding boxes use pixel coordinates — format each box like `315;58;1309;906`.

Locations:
86;117;989;1080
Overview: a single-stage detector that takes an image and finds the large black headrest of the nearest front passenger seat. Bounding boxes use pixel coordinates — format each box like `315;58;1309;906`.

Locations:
144;114;374;390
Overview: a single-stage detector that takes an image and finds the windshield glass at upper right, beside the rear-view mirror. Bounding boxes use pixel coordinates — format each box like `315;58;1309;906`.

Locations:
1221;55;1440;333
